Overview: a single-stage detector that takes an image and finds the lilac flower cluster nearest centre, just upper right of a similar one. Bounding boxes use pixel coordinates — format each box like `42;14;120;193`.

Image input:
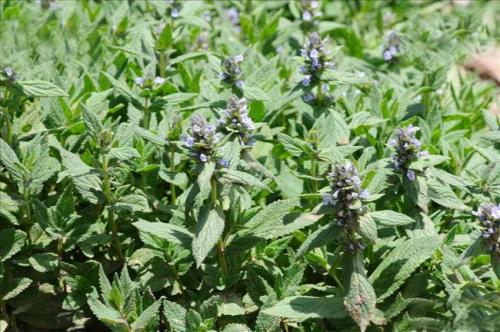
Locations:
219;96;255;145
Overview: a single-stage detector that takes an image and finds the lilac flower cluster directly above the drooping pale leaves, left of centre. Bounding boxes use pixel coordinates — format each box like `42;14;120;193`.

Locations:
183;114;222;163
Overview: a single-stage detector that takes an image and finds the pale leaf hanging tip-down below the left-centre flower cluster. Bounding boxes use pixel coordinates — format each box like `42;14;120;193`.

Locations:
192;208;224;267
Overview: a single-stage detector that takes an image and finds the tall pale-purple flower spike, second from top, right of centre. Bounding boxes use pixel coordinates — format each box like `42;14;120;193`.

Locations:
300;32;333;87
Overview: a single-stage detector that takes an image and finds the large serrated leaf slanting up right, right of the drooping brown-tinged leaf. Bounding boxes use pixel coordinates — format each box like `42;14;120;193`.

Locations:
368;236;441;302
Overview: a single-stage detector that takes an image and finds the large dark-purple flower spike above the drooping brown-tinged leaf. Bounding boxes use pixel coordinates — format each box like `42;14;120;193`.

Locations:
323;162;368;229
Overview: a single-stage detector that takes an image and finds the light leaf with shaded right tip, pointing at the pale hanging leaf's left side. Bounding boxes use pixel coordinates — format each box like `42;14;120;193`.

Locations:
132;219;193;248
